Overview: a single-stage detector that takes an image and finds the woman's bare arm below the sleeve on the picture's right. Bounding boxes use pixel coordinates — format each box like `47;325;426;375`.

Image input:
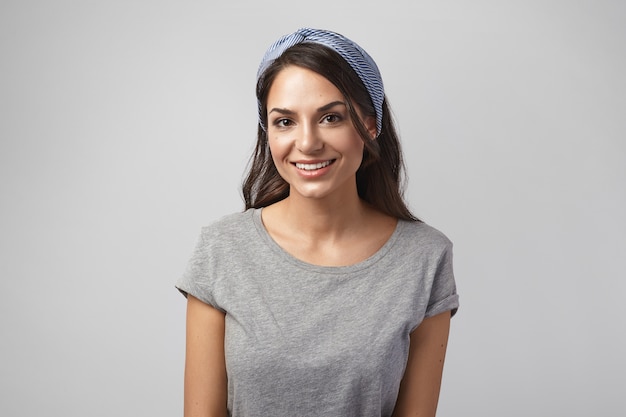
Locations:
393;311;450;417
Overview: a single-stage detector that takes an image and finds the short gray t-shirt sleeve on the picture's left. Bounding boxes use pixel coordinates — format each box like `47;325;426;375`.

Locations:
175;229;223;311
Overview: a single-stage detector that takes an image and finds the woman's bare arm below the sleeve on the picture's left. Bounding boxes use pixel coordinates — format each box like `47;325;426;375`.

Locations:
185;295;227;417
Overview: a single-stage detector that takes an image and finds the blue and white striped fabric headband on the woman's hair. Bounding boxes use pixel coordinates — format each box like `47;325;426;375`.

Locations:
257;28;385;135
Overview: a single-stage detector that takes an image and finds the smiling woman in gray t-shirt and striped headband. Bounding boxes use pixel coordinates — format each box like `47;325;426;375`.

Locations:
177;29;458;417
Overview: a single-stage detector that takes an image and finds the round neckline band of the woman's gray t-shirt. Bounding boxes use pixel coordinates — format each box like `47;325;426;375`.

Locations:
251;208;406;274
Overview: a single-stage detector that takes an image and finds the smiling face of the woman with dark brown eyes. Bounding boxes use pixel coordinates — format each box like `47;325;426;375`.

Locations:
267;66;376;199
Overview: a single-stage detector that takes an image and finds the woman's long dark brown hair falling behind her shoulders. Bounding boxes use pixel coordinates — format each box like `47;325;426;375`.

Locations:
242;43;418;220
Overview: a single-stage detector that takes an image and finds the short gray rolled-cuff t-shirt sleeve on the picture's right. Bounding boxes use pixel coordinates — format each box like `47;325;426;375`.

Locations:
425;241;459;317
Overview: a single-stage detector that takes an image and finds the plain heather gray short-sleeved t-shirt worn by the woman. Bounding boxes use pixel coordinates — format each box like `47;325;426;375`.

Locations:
176;209;459;417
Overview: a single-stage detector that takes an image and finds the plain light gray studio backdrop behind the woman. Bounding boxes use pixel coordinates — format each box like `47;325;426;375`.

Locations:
0;0;626;417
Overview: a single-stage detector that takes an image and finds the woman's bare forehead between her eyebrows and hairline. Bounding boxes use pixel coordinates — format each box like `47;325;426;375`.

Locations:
267;65;343;108
